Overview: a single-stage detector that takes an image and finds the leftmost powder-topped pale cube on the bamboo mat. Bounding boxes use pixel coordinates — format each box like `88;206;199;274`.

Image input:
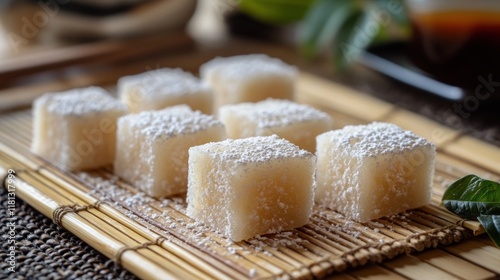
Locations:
31;87;127;170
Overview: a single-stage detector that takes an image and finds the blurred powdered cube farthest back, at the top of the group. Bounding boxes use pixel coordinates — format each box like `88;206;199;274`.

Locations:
200;54;297;109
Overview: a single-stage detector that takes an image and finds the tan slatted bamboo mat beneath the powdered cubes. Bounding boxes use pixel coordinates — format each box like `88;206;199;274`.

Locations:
0;71;500;279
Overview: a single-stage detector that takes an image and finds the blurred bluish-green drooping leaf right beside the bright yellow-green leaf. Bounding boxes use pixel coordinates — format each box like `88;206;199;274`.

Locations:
298;0;354;58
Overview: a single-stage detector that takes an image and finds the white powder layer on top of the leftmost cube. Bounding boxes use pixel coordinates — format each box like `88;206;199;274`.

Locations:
33;86;127;116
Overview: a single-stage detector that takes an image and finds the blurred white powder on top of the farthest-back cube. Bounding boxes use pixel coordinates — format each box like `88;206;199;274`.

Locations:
200;54;297;80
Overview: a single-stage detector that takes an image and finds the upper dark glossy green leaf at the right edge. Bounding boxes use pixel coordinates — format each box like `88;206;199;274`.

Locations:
442;175;500;219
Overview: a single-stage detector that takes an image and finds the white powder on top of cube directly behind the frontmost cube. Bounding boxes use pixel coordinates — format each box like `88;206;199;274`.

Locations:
219;99;331;128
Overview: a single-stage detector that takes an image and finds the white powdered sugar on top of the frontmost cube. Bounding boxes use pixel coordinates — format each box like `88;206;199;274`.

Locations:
191;135;314;164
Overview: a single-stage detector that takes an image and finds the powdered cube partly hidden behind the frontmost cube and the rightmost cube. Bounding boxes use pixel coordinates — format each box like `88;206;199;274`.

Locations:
219;99;332;153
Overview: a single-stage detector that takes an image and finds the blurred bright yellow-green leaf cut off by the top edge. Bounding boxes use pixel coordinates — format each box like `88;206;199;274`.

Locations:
239;0;315;24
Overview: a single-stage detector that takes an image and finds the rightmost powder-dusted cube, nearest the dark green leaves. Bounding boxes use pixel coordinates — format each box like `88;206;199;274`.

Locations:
316;122;436;222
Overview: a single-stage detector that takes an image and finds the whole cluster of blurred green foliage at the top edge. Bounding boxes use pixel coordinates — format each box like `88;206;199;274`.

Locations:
240;0;409;69
